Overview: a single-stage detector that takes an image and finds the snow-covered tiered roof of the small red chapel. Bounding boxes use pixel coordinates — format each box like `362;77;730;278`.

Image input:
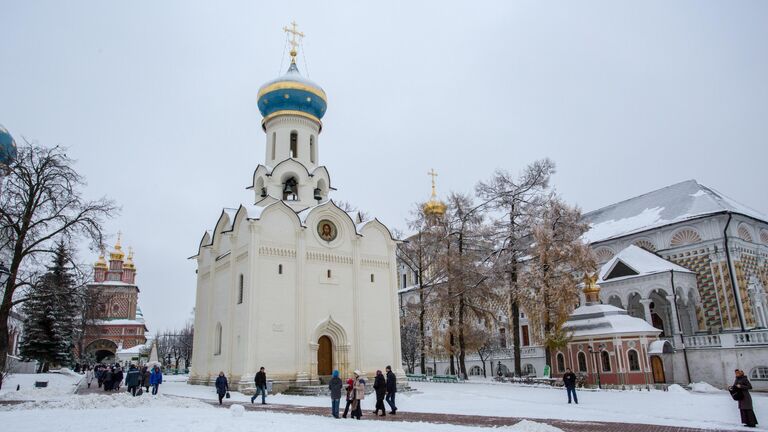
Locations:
563;304;661;338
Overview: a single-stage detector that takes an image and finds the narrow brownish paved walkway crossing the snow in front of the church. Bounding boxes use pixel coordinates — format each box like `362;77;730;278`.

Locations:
67;382;727;432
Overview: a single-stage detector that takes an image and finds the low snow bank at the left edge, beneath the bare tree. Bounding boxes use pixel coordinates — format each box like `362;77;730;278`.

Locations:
0;369;84;400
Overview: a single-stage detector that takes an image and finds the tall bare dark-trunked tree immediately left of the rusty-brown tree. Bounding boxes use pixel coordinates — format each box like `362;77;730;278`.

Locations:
475;159;555;376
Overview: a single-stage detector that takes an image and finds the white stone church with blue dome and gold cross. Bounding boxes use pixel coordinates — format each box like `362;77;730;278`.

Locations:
189;26;404;391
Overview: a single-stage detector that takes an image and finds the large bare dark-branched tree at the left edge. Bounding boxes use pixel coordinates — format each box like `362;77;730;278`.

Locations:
0;141;116;370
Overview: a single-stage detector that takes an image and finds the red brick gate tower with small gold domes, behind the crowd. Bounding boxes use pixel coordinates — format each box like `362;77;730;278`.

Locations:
84;236;147;362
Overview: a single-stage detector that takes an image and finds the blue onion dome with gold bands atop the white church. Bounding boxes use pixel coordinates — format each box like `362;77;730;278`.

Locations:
259;62;328;126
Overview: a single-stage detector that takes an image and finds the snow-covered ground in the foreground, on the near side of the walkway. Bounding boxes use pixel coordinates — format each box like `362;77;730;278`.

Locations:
0;393;561;432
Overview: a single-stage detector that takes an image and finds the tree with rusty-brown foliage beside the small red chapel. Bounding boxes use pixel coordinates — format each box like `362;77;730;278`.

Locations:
520;196;597;365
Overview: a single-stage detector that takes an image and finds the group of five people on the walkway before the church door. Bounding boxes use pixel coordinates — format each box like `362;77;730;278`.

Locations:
328;366;397;420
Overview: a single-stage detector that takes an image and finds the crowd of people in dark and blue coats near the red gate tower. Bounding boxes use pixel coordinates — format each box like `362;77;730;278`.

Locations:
85;364;163;396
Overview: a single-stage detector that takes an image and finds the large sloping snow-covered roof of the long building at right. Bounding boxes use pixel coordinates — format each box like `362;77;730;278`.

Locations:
583;180;768;243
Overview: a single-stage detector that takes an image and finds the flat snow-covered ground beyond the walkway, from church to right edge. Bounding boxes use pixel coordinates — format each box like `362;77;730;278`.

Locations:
160;376;768;429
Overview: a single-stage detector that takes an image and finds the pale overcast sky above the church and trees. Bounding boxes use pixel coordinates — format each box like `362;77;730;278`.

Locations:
0;0;768;332
